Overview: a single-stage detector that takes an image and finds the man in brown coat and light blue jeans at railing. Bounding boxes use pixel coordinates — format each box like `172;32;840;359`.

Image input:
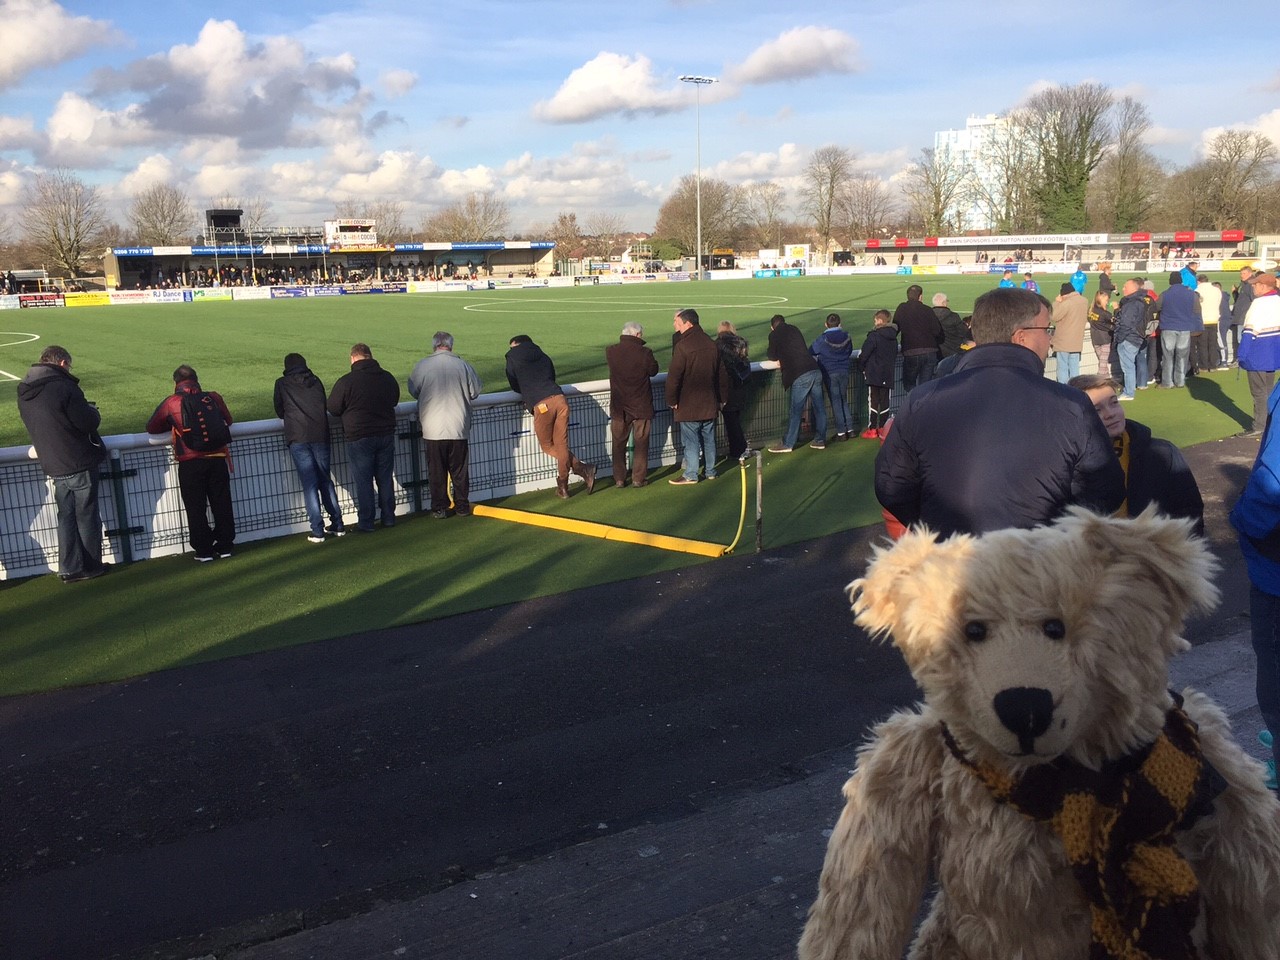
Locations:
667;310;728;486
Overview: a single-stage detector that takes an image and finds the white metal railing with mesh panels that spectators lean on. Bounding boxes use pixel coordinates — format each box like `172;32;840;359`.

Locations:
0;364;897;579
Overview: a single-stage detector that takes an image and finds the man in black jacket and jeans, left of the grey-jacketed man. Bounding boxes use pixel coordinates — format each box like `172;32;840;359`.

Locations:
325;343;399;534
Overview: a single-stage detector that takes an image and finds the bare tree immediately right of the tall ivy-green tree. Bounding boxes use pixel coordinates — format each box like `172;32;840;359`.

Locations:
1085;97;1165;233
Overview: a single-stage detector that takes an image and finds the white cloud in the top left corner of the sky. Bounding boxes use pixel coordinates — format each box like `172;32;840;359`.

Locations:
0;0;120;90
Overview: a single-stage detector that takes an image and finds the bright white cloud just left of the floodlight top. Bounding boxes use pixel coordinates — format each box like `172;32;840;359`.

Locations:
534;52;692;123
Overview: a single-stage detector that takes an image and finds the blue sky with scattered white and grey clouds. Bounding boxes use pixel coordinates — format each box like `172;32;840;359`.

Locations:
0;0;1280;232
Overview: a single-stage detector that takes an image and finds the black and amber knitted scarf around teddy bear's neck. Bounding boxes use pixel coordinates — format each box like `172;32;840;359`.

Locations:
942;694;1225;960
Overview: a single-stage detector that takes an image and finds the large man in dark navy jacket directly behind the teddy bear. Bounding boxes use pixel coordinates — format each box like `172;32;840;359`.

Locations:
876;288;1124;536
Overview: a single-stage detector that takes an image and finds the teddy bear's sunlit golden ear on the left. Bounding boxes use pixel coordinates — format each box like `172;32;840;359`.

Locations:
847;527;973;663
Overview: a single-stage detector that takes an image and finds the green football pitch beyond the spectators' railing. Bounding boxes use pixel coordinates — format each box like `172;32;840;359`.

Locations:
0;274;1234;447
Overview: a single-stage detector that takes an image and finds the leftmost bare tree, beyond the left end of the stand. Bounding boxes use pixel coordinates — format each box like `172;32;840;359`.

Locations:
23;168;106;276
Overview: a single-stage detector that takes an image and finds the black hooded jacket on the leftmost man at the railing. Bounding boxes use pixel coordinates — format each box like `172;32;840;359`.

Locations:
18;364;106;476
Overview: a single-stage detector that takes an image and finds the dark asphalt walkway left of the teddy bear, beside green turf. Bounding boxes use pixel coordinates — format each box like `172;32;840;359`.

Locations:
0;439;1257;960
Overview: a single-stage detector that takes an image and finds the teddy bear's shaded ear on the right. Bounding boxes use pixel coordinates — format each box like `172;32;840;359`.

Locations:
1059;507;1219;625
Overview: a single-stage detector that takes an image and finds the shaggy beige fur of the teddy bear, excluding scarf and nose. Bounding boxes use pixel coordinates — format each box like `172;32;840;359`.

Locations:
800;511;1280;960
